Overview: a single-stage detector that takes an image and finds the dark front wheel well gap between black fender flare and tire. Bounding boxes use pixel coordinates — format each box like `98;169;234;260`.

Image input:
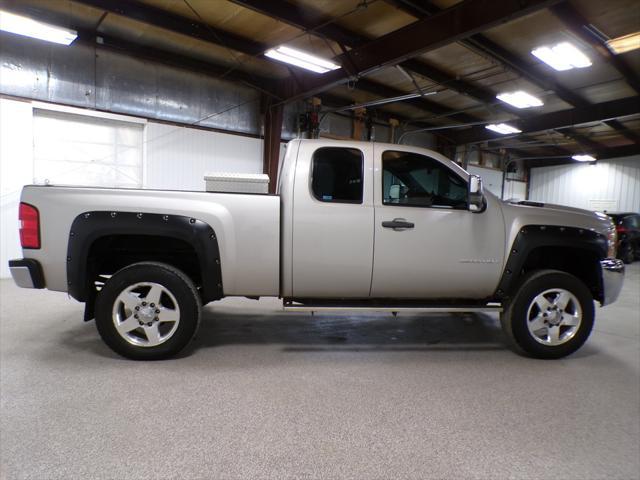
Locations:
521;246;603;302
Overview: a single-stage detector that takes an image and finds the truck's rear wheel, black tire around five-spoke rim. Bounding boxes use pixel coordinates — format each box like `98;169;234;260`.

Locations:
95;262;202;360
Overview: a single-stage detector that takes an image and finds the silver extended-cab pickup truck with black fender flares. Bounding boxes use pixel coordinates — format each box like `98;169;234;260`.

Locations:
10;140;624;359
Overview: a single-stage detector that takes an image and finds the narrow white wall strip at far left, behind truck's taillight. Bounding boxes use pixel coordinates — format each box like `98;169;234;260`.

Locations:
0;98;33;278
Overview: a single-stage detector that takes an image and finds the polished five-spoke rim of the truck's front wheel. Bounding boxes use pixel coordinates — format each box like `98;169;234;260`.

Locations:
527;288;582;346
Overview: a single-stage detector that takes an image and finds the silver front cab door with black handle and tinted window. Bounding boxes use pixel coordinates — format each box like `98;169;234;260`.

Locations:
371;145;505;299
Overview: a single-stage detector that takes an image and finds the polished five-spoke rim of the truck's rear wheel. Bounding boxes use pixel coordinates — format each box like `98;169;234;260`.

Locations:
112;282;180;347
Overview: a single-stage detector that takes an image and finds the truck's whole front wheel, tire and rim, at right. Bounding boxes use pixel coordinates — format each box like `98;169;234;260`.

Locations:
500;270;594;358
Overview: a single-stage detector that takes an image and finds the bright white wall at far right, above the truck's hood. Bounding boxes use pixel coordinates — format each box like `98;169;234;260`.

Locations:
529;155;640;212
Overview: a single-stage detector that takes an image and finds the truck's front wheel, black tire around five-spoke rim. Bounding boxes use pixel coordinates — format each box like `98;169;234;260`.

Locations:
500;270;594;359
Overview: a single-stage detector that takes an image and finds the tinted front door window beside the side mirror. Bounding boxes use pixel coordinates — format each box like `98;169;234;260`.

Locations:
382;151;467;209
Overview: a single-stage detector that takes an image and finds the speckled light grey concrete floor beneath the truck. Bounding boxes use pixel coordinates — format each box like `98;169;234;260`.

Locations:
0;263;640;480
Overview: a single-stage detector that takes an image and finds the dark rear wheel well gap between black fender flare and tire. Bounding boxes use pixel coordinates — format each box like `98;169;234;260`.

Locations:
87;235;202;288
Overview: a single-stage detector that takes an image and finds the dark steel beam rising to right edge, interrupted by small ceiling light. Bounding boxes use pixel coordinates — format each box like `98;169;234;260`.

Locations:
454;97;640;144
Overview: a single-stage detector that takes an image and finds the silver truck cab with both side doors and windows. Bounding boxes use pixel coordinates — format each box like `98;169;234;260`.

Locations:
279;140;505;299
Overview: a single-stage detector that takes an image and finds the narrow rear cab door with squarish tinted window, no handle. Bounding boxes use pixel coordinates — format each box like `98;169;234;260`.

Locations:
291;141;374;298
